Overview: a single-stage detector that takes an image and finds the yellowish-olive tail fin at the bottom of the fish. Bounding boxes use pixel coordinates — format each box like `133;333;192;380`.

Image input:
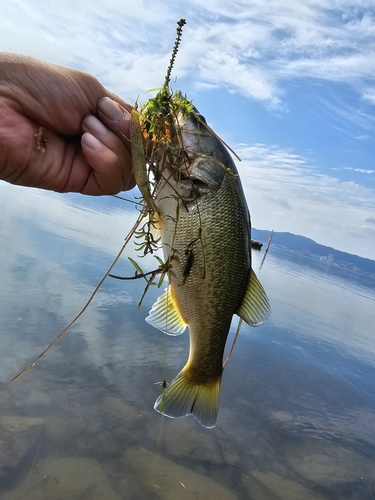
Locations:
154;368;221;428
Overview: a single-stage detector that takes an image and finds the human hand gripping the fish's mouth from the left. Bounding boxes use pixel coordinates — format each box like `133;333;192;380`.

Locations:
0;52;135;195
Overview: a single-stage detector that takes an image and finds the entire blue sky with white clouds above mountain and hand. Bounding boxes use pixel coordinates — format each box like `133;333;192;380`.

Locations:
0;0;375;259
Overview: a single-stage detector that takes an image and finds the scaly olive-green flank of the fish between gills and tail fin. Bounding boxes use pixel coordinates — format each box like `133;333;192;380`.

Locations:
171;184;250;382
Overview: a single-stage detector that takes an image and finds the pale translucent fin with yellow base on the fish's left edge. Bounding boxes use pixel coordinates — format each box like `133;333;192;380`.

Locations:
146;286;187;335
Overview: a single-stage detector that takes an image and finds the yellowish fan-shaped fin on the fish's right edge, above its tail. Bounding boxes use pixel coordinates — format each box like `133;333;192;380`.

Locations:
237;270;271;326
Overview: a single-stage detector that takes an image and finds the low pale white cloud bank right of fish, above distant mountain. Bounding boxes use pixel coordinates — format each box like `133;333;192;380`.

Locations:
236;144;375;259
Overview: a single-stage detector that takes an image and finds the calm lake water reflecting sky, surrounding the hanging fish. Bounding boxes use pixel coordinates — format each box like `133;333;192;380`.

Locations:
0;183;375;500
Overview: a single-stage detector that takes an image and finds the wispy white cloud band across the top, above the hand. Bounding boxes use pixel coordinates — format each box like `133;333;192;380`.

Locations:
0;0;375;107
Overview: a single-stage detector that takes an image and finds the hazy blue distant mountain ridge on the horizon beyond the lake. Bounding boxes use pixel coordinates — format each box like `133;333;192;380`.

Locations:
251;228;375;275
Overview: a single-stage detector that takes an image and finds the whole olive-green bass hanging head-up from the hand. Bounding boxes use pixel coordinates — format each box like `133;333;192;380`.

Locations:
146;98;270;428
